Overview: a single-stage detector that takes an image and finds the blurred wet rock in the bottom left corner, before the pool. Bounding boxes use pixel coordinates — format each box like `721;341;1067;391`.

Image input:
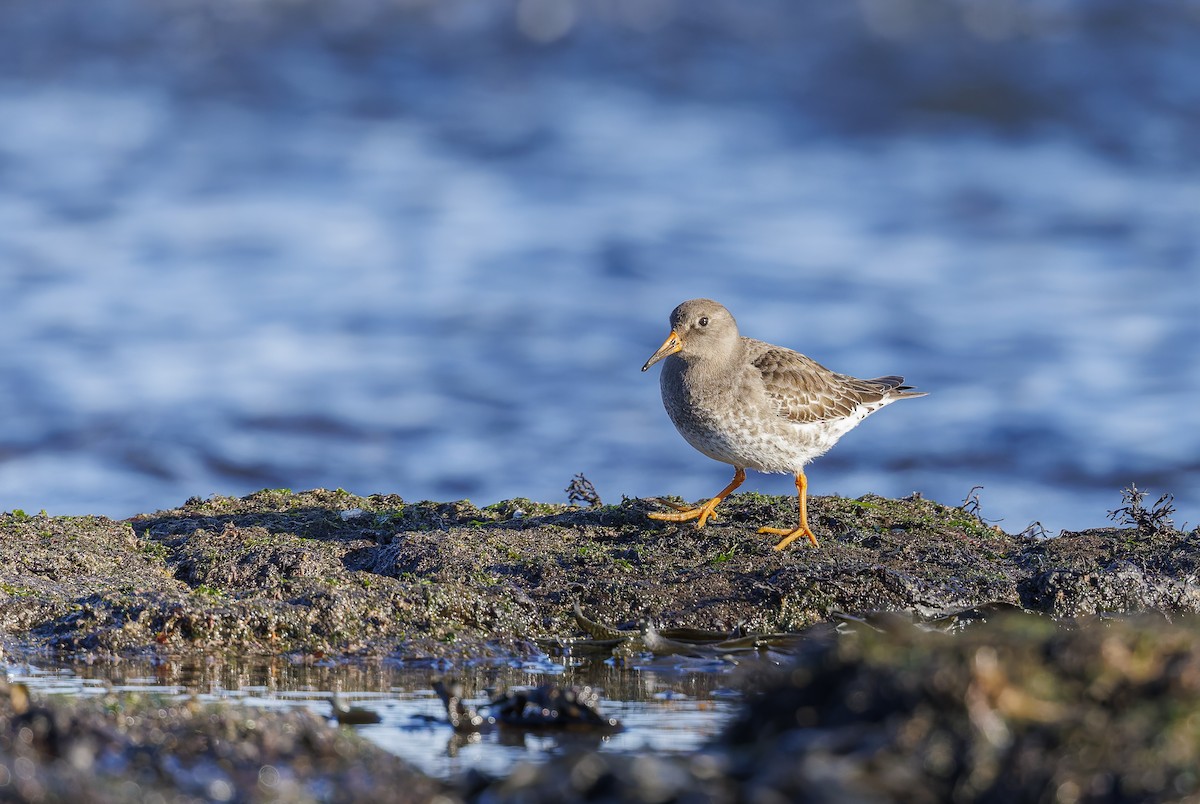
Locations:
0;680;457;803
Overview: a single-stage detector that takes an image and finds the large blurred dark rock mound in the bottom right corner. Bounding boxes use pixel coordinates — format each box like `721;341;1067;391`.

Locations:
478;614;1200;803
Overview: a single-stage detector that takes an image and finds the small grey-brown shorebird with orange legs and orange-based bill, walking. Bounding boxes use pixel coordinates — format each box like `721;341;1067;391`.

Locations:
642;299;925;550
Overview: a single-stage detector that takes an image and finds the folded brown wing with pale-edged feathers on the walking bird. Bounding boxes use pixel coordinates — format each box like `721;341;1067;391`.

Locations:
746;338;900;422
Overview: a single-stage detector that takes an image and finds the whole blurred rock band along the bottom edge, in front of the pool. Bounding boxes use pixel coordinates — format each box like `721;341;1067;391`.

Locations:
0;613;1200;804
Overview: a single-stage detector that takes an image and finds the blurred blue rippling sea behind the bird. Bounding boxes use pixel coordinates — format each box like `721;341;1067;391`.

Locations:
0;0;1200;532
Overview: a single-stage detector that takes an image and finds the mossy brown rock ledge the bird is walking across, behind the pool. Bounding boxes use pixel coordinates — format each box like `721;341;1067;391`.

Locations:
0;490;1200;658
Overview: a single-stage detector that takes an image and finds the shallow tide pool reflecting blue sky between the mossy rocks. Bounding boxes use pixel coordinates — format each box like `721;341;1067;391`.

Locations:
4;658;738;778
